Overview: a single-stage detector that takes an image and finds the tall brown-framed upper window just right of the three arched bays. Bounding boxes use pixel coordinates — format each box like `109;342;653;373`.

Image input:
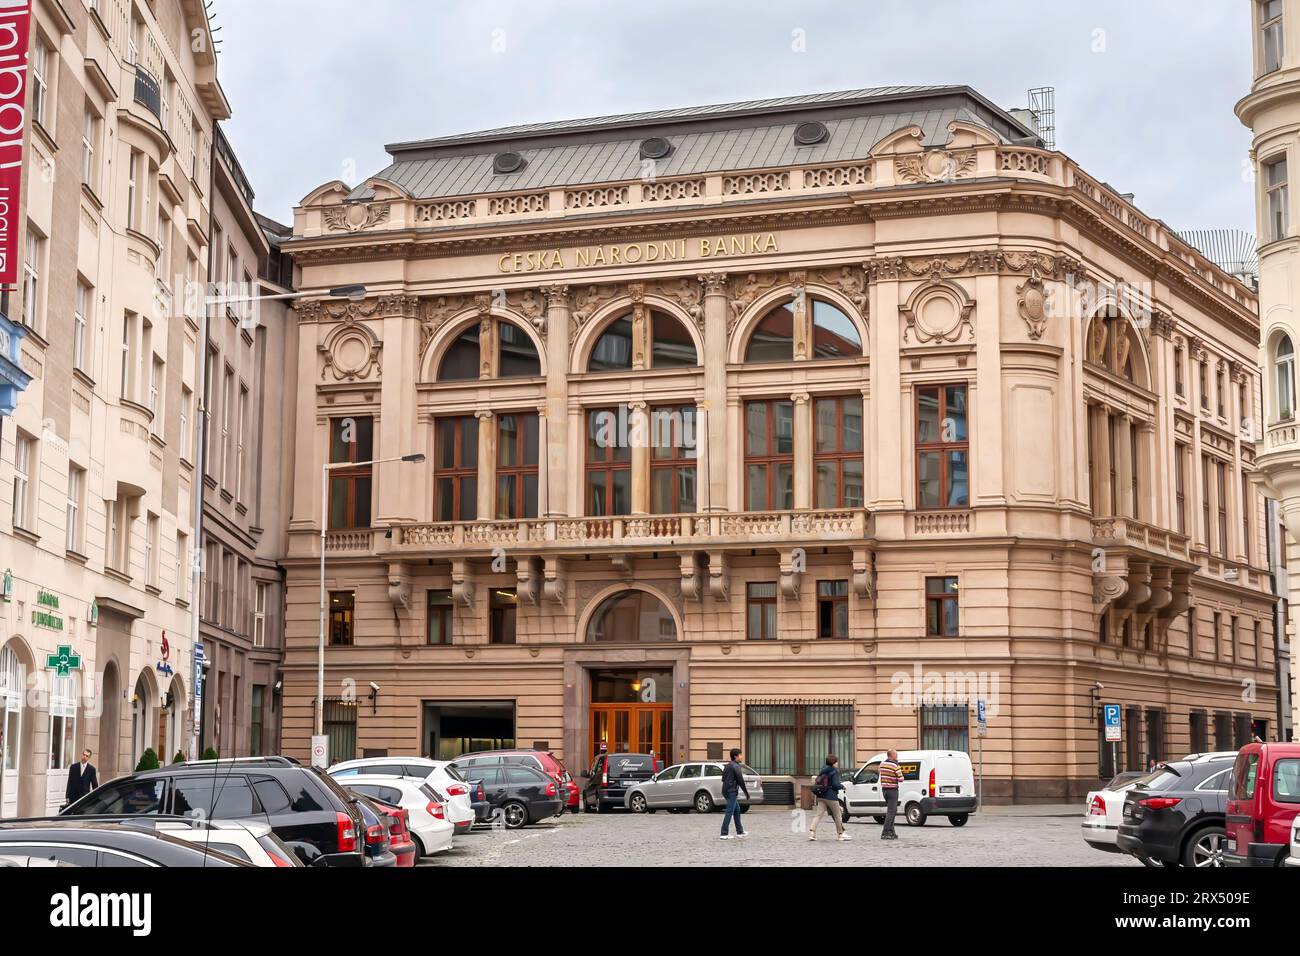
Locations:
917;385;970;509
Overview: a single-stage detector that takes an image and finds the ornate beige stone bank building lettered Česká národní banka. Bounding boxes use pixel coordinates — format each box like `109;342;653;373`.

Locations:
283;87;1277;800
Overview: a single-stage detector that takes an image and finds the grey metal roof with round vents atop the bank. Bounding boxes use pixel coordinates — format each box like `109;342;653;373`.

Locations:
348;86;1034;200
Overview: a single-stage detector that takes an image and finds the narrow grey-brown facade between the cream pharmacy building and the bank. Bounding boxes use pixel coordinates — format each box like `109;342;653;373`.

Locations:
198;130;298;757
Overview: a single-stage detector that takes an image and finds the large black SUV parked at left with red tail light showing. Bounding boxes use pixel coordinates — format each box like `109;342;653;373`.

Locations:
64;757;369;866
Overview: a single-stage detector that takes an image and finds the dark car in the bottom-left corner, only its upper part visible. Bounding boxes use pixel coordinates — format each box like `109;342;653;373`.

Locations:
0;817;248;869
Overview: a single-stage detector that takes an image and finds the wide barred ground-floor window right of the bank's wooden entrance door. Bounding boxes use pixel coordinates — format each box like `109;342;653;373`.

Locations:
745;702;854;777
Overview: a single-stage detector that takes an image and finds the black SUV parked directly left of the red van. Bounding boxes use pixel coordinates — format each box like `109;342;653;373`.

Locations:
1115;754;1232;866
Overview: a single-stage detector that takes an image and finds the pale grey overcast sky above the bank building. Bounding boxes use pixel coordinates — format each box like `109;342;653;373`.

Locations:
215;0;1255;239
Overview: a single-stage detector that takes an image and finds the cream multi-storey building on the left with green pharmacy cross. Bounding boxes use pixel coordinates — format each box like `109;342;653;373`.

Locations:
0;0;229;817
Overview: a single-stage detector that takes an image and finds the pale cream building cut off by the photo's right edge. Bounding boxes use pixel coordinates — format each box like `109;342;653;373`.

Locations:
1236;0;1300;727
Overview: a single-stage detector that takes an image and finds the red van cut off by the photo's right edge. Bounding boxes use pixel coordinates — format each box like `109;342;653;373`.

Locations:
1223;743;1300;866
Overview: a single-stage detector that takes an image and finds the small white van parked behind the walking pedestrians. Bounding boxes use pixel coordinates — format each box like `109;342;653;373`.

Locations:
840;750;978;826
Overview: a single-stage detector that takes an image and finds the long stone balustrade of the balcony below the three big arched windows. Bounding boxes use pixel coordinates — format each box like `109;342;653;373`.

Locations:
325;509;872;553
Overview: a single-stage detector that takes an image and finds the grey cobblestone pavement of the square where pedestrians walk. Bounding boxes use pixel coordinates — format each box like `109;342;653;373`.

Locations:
420;808;1140;866
